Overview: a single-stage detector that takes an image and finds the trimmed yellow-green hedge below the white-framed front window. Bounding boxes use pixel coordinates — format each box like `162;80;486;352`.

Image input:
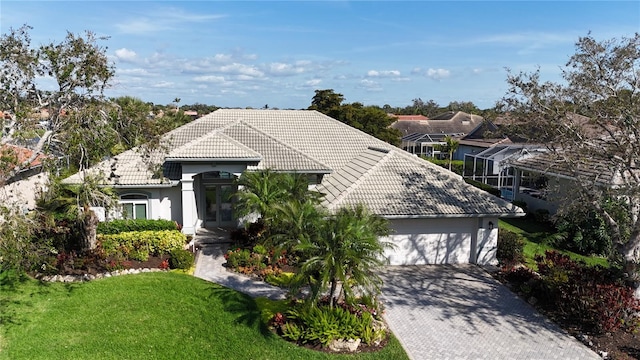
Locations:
98;230;187;258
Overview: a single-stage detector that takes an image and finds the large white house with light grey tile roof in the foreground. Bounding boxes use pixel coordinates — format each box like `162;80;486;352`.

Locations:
65;109;524;265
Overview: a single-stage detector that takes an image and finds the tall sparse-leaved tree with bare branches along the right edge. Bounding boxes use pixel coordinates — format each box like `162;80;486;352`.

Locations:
501;33;640;290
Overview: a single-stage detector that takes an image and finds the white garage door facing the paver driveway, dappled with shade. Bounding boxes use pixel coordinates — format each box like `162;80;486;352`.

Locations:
385;219;478;265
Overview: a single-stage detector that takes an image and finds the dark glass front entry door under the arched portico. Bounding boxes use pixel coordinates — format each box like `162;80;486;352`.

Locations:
204;184;235;227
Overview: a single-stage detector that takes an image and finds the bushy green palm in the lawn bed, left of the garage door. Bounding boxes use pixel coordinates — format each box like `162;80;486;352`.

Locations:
296;205;391;307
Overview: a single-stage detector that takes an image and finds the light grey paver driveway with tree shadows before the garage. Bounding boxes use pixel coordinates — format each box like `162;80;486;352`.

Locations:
381;265;600;360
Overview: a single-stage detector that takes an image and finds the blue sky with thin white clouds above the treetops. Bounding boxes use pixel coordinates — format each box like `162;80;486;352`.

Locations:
0;0;640;109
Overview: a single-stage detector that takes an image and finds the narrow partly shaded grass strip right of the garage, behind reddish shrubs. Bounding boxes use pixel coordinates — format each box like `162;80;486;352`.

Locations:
499;219;609;270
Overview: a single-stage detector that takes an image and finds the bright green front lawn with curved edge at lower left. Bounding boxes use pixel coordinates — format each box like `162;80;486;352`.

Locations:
0;273;407;360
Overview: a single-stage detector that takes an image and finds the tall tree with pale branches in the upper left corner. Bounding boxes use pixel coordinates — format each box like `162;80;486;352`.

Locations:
0;25;115;172
